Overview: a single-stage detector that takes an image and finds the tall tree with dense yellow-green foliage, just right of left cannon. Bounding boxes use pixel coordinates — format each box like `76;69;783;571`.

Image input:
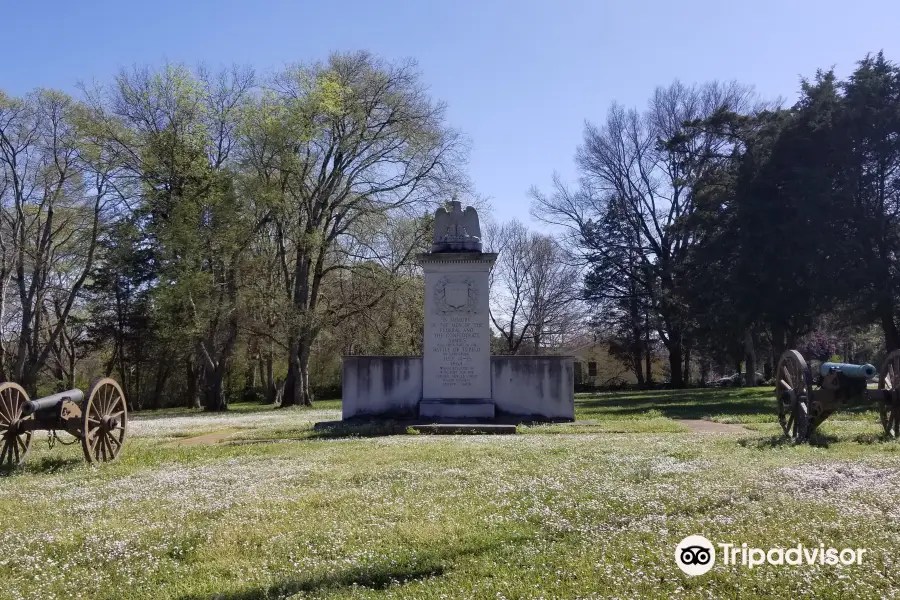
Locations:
81;64;258;410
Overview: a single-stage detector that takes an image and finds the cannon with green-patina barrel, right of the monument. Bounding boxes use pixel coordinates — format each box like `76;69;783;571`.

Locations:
775;350;900;442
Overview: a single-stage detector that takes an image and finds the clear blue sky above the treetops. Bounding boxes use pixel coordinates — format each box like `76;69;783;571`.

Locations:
0;0;900;221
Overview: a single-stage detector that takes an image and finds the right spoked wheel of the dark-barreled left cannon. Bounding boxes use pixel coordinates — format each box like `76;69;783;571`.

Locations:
81;378;128;463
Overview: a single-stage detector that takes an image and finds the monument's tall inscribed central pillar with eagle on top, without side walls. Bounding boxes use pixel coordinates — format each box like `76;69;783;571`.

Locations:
419;200;497;419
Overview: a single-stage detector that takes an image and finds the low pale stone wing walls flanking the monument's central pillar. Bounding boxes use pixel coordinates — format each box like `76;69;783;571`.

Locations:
342;356;575;421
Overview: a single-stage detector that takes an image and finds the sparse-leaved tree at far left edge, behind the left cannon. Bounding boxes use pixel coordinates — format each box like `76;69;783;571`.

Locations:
0;90;110;393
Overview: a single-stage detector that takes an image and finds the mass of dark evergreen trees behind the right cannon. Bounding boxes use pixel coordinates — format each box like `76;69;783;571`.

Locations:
672;55;900;370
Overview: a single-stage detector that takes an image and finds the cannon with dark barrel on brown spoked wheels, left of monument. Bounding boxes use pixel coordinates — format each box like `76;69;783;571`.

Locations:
0;377;128;468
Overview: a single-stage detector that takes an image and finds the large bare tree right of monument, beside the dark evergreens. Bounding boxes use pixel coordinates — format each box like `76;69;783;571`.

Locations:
533;81;754;387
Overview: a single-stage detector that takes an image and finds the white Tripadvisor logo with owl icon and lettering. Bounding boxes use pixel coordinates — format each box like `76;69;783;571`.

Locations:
675;535;868;576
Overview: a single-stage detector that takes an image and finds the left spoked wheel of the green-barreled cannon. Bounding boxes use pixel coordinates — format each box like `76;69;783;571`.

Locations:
775;350;812;441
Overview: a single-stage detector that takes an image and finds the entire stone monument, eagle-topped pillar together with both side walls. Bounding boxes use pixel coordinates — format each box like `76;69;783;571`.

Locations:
341;199;575;423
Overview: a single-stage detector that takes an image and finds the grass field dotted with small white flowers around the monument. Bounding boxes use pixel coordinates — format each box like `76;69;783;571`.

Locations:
0;388;900;600
